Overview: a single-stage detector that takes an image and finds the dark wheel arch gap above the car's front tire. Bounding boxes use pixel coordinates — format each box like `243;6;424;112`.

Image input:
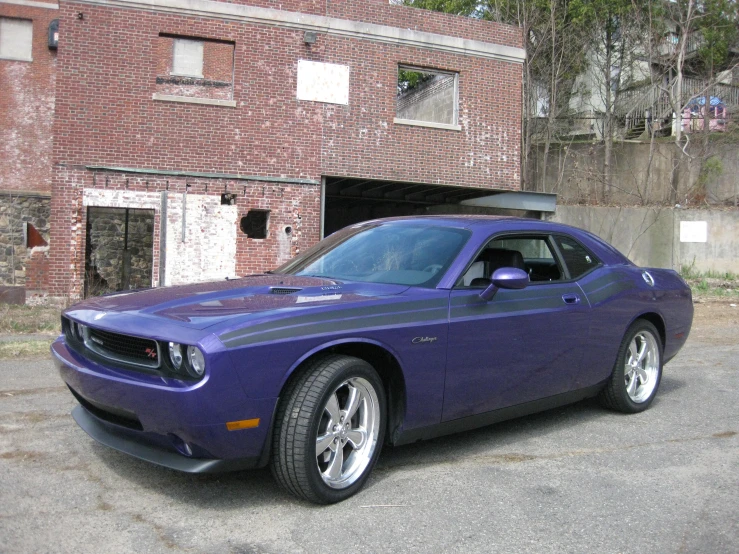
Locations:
280;338;406;442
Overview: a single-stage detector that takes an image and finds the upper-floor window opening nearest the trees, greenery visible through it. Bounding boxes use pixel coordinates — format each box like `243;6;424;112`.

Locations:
395;65;458;128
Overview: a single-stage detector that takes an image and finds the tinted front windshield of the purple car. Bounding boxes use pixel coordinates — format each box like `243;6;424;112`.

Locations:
274;222;470;287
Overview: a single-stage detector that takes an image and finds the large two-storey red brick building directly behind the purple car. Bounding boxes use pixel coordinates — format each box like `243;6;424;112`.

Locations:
21;0;523;297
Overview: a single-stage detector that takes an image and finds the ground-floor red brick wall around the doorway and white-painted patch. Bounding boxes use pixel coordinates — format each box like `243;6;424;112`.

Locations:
47;167;320;298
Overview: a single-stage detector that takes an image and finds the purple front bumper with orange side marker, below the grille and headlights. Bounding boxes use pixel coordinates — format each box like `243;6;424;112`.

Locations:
51;339;277;466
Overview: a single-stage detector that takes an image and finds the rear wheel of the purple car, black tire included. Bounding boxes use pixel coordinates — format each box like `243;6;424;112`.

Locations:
598;319;662;414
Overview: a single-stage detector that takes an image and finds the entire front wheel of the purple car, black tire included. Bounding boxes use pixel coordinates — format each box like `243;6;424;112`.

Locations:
272;355;387;504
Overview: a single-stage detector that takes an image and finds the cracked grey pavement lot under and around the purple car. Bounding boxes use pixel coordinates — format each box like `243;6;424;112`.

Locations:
0;302;739;553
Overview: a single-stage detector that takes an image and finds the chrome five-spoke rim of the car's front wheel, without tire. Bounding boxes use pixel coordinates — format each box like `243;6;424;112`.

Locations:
316;377;380;489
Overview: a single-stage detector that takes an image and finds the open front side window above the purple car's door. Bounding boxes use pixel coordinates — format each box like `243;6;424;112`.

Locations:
457;236;562;287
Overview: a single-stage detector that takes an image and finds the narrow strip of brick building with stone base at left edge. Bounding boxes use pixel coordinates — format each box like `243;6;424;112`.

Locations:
0;0;59;302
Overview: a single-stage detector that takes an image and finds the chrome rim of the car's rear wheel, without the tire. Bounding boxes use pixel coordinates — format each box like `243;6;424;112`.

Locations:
624;330;660;403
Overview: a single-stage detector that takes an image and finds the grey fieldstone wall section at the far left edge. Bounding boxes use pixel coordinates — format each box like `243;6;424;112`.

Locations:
0;191;51;286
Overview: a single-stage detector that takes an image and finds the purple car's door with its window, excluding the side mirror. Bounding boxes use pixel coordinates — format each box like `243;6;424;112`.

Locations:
442;234;591;421
